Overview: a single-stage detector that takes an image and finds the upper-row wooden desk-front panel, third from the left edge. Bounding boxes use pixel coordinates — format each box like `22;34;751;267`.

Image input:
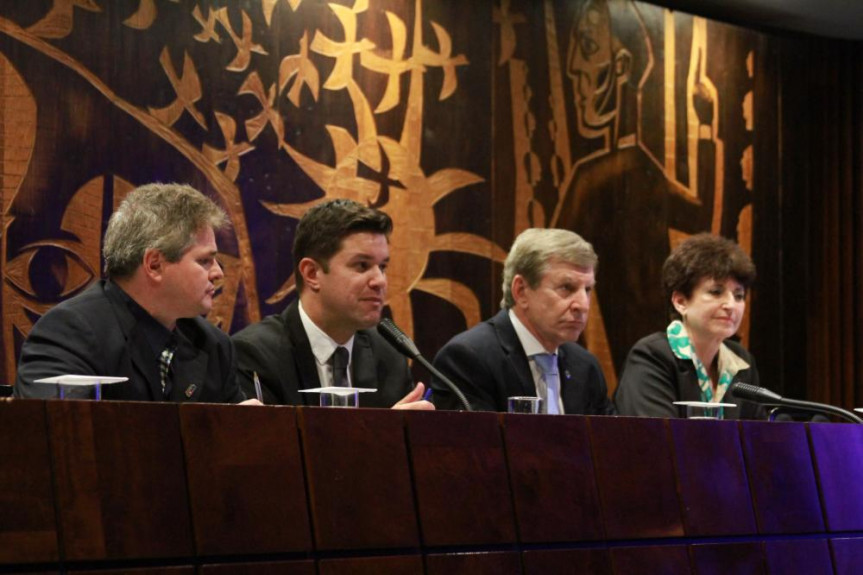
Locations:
180;404;312;555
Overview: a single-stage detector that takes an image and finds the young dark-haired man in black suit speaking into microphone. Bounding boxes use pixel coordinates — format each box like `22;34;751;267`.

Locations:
233;199;434;409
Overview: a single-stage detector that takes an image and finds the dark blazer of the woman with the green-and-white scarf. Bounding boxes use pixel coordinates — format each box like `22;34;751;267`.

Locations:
614;332;766;419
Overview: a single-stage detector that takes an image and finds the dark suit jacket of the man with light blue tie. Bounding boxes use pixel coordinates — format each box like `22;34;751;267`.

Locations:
432;310;615;415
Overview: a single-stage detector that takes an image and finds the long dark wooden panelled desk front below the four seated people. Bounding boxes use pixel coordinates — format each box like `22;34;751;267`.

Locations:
0;400;863;575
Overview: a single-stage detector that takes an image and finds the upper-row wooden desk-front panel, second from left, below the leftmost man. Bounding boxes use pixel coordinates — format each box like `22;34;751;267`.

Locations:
46;401;194;560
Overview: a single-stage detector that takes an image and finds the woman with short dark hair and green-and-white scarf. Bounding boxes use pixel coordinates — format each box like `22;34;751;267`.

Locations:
615;234;764;419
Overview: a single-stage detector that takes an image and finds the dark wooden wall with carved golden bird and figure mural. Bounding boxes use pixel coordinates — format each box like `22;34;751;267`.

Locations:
0;0;863;407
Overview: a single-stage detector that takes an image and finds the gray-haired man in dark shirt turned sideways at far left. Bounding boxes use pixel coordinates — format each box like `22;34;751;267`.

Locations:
15;184;258;403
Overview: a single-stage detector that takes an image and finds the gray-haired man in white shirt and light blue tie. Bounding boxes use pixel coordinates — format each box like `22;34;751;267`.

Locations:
432;228;615;415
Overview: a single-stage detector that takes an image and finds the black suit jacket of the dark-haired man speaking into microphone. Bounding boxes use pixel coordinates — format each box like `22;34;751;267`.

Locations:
233;301;413;407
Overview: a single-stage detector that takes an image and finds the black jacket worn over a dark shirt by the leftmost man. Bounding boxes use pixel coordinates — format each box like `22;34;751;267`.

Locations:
15;280;246;403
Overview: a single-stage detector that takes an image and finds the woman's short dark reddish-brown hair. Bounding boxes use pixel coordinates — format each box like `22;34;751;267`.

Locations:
662;234;755;319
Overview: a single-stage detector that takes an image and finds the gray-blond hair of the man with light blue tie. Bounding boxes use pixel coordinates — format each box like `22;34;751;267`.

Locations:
500;228;599;309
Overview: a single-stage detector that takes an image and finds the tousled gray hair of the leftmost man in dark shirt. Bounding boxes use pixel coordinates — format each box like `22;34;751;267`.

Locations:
102;183;228;278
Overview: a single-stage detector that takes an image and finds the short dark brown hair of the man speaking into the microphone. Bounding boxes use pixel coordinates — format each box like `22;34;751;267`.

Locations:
293;199;393;293
